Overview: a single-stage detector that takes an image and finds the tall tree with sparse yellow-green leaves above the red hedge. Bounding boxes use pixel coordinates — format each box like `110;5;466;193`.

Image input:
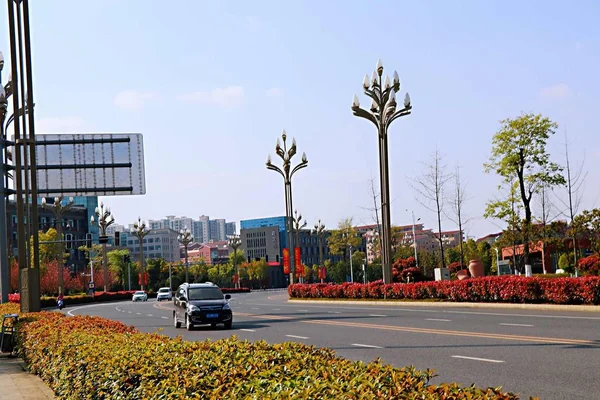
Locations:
484;114;565;264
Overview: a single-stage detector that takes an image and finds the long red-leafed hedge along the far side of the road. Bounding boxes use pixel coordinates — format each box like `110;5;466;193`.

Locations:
288;276;600;305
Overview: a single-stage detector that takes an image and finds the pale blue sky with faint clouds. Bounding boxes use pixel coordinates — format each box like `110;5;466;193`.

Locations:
0;0;600;237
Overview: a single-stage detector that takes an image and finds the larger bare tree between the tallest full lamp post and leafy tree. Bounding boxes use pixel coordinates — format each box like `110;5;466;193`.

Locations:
413;149;452;268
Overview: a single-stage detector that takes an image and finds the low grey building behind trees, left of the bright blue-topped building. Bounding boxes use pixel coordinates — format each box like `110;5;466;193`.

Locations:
121;228;180;262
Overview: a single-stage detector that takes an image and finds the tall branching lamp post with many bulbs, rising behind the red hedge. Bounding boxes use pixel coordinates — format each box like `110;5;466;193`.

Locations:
352;60;412;283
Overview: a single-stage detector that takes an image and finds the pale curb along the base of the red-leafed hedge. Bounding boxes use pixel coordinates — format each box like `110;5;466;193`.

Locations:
288;299;600;313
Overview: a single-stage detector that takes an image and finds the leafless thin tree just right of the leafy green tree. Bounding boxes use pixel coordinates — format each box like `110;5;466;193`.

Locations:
558;129;587;265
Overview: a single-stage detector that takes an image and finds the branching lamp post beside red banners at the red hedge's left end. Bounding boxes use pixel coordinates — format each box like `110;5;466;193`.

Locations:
266;130;308;284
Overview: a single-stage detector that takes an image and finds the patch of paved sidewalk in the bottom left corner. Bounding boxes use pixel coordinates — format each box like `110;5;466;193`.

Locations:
0;354;55;400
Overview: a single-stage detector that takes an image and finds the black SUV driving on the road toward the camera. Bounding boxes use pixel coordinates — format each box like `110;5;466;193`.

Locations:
173;282;233;331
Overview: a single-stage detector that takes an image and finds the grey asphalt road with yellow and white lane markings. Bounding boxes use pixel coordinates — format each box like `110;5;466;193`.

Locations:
63;291;600;399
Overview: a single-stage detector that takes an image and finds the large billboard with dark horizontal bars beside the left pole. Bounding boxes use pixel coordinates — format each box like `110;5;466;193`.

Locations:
26;133;146;197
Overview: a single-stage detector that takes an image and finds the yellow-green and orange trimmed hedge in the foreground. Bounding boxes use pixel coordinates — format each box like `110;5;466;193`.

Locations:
11;312;518;400
